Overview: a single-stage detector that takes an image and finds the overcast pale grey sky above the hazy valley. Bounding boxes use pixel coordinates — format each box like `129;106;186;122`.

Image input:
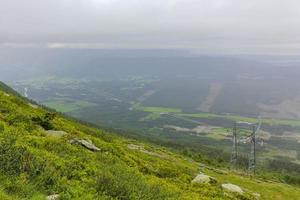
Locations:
0;0;300;54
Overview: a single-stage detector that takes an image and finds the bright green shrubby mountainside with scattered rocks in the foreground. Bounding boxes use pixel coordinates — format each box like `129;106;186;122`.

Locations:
0;83;300;200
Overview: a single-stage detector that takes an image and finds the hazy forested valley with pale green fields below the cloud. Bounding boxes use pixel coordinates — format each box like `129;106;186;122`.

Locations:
2;49;300;171
